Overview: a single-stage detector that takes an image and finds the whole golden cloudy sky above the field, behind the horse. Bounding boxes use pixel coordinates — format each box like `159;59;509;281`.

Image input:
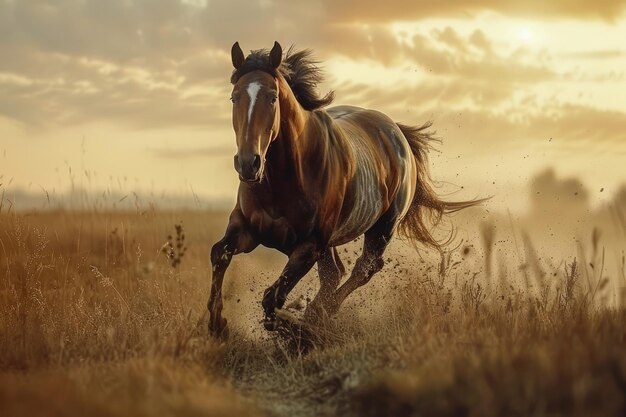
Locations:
0;0;626;211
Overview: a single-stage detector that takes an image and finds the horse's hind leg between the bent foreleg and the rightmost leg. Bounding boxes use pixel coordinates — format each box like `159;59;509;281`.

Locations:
305;247;346;322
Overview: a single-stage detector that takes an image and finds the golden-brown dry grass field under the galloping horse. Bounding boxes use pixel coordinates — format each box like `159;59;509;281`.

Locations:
0;206;626;417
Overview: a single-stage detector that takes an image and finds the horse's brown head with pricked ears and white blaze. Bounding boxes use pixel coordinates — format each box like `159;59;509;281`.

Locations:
231;42;283;183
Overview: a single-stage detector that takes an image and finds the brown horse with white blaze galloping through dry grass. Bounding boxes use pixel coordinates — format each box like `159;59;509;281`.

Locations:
208;42;480;335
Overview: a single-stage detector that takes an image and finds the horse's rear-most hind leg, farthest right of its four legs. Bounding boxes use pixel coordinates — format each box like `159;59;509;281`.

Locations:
326;222;394;314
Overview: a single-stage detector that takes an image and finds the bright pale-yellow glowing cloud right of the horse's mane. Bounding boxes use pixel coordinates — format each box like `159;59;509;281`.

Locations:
326;27;559;111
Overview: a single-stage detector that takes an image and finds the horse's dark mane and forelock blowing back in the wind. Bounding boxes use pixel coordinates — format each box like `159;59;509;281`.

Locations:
230;46;335;110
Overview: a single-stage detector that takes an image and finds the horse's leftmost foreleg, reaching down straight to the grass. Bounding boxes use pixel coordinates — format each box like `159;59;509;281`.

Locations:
207;209;258;336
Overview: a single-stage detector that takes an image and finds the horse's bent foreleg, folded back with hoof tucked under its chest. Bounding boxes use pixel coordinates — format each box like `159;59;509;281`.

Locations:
261;242;322;330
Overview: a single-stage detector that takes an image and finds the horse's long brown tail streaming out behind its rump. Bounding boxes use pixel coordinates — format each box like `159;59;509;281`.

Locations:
398;122;488;250
